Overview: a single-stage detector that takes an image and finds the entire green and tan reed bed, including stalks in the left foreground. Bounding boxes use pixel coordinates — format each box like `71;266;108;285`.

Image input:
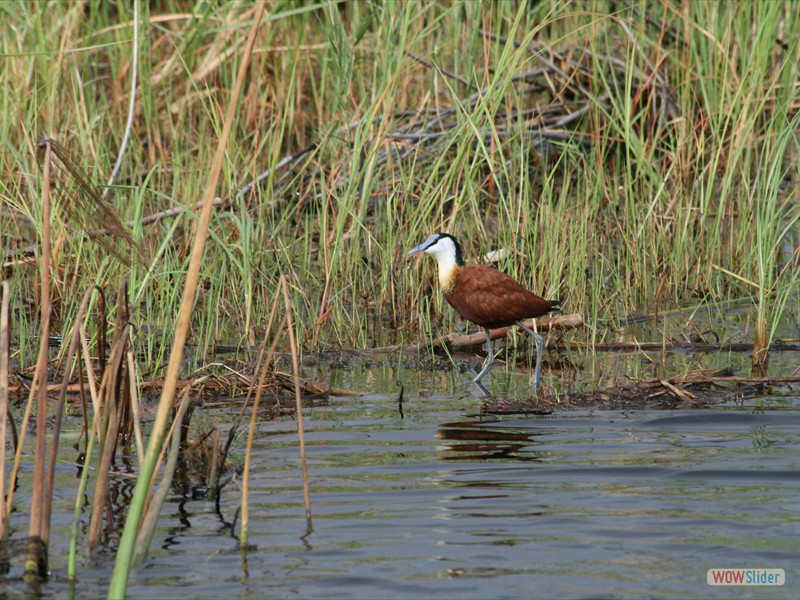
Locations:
0;0;800;596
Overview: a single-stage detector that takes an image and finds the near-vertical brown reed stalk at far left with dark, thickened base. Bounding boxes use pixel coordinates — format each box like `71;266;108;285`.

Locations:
25;140;53;579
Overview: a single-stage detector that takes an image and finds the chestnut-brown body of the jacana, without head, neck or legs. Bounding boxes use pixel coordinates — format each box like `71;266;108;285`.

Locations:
443;265;558;329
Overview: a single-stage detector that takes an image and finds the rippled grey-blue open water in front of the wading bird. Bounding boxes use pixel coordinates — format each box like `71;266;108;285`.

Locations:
6;369;800;598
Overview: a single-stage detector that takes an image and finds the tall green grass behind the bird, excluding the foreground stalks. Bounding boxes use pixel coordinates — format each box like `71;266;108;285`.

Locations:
0;2;799;374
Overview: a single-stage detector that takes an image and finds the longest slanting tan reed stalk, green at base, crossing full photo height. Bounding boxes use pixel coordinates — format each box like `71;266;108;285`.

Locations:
109;2;265;597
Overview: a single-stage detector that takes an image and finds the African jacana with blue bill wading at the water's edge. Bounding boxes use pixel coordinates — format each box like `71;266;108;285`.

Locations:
406;233;559;393
